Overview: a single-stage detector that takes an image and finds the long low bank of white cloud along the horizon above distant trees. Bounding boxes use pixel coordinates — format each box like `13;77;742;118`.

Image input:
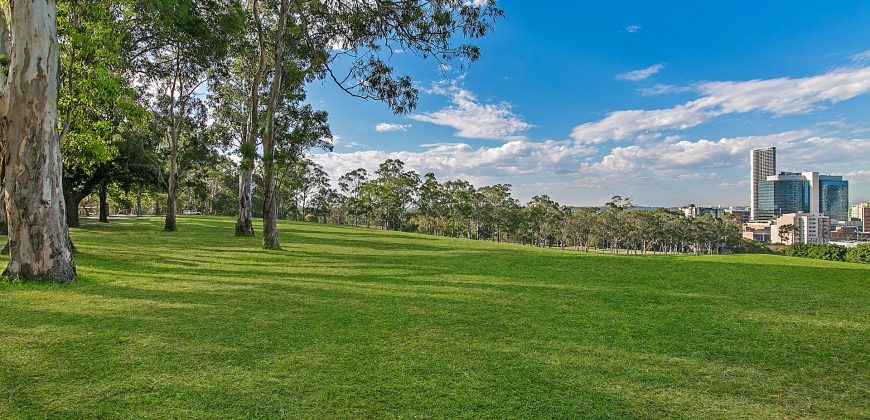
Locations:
311;130;870;205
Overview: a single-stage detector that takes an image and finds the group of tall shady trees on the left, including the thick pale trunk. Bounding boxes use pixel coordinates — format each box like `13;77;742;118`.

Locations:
0;0;502;281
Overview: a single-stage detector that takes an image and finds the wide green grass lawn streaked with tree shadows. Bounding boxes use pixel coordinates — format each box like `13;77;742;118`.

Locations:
0;217;870;418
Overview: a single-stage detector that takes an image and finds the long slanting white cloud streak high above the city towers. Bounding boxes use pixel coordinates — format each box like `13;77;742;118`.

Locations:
571;67;870;143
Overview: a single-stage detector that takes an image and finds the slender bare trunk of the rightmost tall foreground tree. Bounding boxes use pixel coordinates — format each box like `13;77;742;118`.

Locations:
260;0;289;249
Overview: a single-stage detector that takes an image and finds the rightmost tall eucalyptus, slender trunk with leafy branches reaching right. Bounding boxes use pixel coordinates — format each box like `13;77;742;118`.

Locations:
259;0;502;248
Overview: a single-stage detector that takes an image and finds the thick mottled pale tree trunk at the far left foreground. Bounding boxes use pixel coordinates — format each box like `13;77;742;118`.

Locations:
0;0;76;282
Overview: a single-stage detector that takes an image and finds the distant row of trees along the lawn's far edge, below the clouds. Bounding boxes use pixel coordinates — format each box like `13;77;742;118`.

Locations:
189;159;745;253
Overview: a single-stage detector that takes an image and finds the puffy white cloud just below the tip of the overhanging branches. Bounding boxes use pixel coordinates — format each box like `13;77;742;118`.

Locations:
410;84;532;140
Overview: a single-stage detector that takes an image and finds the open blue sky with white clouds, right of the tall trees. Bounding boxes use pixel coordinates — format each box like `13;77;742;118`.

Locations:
309;0;870;206
